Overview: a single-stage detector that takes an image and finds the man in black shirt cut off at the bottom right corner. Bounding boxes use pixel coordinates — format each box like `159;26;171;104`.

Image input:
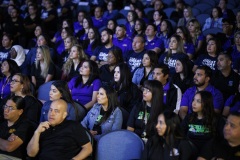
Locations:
198;112;240;160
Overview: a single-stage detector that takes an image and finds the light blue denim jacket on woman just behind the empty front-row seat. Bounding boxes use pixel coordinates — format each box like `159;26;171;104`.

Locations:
81;103;123;140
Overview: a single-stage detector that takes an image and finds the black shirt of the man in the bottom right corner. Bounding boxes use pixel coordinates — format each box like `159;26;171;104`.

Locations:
199;139;240;160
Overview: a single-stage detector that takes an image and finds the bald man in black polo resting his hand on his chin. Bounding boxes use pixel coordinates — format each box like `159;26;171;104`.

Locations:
27;99;92;160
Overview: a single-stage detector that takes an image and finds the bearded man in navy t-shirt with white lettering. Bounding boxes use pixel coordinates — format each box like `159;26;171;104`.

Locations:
90;28;120;67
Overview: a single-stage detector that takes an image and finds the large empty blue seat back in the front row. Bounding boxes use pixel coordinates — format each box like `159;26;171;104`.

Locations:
96;130;144;160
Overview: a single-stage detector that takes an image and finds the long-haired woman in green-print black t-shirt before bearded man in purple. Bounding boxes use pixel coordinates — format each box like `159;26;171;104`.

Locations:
182;91;225;153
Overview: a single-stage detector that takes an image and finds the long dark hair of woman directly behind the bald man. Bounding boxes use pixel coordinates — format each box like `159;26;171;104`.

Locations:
52;80;79;120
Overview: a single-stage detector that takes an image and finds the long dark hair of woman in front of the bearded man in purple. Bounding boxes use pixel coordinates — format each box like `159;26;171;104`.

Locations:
190;91;216;135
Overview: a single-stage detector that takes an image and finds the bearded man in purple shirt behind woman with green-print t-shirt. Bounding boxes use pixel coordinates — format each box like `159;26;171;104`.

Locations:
179;66;224;119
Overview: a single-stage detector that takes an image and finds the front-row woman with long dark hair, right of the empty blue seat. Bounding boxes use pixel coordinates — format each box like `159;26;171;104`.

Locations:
141;111;194;160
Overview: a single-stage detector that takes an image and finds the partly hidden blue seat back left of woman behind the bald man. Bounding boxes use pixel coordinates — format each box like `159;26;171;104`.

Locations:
37;81;54;101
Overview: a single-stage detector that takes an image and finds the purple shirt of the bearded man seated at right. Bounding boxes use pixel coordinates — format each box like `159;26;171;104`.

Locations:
180;84;224;114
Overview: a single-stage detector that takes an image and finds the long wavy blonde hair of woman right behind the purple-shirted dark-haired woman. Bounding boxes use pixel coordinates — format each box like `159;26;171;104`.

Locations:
62;44;88;75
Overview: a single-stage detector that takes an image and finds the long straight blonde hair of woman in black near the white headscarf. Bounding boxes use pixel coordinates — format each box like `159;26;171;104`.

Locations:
35;45;52;78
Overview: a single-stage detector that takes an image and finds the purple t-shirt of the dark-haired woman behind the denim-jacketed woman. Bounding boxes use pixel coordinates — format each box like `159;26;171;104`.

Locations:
68;77;101;105
